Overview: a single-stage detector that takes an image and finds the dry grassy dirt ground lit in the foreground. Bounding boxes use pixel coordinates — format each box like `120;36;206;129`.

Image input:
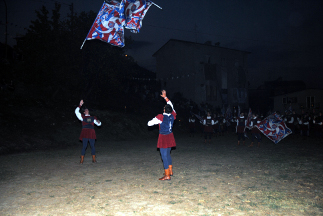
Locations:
0;126;323;216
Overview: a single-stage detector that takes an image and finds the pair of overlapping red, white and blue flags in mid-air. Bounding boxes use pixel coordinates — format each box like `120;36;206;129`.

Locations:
81;0;160;49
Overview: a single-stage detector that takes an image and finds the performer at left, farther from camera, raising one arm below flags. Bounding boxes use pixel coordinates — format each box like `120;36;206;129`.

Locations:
75;100;101;164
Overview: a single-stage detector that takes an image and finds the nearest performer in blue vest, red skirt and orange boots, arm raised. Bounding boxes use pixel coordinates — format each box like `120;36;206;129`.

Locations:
148;90;177;181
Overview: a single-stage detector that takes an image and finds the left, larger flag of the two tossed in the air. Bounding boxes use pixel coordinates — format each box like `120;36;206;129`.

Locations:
85;0;125;47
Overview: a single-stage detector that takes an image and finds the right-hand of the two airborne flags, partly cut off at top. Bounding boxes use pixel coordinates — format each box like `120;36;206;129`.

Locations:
125;0;153;33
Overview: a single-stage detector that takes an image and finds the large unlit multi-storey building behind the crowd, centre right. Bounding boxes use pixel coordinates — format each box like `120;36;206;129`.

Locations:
153;39;249;108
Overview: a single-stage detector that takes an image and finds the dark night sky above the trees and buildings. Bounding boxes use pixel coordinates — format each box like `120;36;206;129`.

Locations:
0;0;323;88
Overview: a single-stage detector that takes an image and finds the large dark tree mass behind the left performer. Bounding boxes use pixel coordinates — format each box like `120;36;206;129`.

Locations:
18;3;136;107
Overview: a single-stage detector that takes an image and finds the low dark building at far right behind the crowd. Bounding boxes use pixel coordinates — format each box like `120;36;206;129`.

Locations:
274;89;323;113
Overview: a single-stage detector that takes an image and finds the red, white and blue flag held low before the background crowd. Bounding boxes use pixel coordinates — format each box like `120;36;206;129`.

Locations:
256;113;292;144
